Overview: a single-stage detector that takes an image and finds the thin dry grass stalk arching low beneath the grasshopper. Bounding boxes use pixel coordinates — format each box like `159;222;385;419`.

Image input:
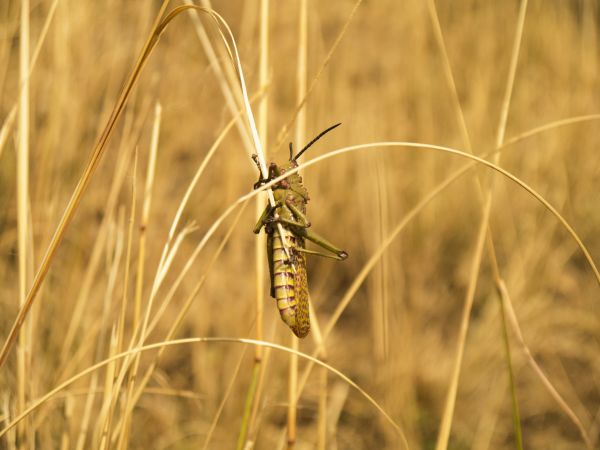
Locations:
0;337;408;448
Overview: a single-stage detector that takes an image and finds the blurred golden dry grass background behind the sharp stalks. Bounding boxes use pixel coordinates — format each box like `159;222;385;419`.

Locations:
0;0;600;449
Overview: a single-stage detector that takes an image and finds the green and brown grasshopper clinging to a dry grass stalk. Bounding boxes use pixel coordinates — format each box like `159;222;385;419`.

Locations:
252;123;348;338
